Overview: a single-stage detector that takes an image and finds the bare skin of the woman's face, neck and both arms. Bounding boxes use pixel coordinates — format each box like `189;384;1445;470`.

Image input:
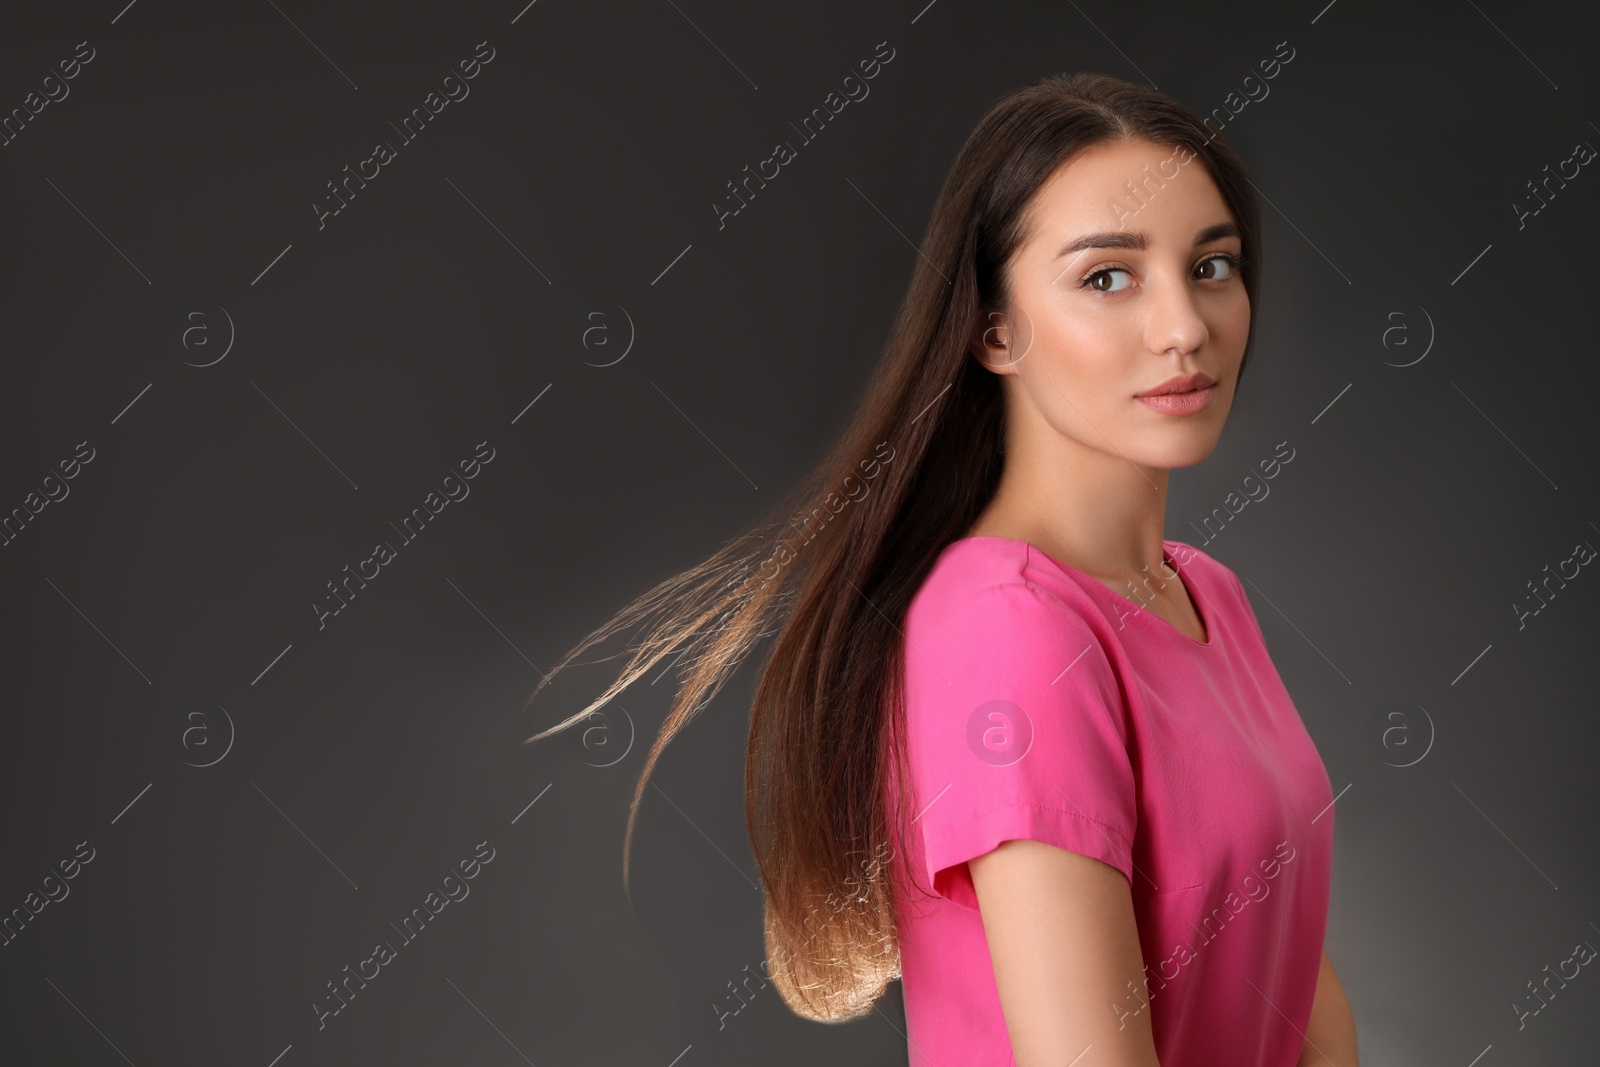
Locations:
968;141;1357;1067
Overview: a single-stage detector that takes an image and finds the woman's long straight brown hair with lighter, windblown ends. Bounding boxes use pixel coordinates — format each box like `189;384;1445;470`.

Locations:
528;74;1261;1022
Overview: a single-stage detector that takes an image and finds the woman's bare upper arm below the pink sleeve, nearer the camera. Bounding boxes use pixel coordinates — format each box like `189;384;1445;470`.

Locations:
966;840;1158;1067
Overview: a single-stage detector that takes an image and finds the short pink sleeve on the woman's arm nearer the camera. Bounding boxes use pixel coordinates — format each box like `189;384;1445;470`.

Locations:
906;581;1136;909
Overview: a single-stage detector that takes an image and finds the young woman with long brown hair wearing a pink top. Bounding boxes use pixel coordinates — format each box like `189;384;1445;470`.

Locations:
530;74;1357;1067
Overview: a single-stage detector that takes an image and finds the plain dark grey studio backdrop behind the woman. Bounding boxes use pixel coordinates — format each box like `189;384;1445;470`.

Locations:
0;0;1600;1067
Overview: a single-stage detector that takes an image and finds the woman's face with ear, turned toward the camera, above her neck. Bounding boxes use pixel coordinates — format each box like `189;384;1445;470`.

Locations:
978;141;1250;469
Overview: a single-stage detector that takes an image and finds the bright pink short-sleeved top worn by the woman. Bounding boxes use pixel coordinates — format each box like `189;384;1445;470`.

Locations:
890;536;1333;1067
